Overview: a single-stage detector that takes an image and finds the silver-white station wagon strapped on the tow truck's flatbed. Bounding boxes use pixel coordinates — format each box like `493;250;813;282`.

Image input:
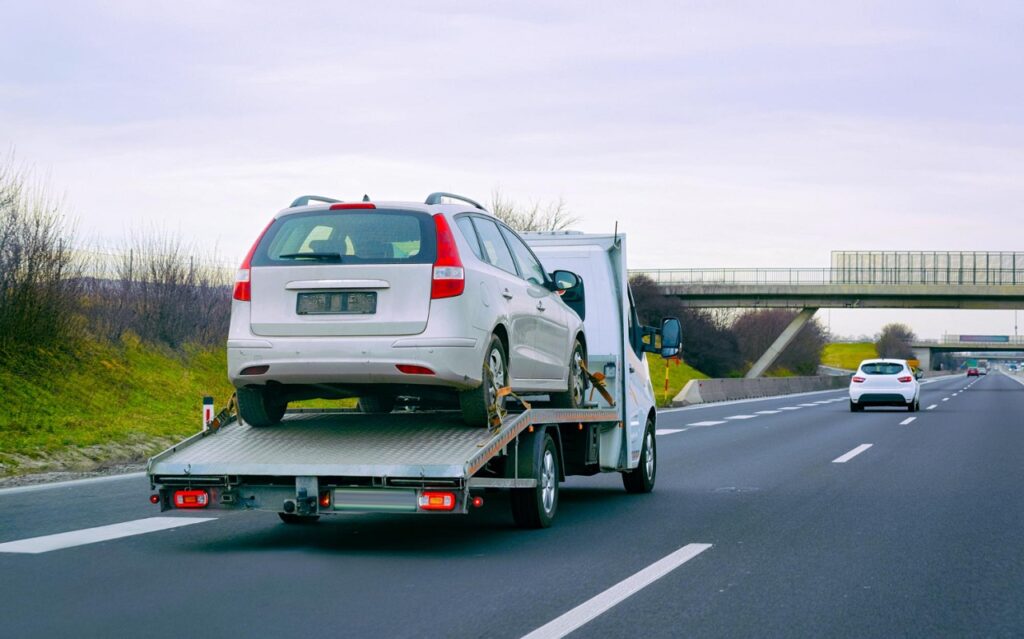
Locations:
227;193;587;426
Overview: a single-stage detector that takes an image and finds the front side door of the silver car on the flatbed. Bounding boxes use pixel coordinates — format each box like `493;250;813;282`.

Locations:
501;226;571;380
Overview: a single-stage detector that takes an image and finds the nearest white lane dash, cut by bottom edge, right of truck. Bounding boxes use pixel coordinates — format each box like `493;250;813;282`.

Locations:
522;544;712;639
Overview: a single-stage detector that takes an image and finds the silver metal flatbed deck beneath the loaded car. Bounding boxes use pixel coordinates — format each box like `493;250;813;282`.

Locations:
148;410;618;478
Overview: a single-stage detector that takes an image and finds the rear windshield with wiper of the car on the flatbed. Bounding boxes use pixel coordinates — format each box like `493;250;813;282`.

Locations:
252;209;435;266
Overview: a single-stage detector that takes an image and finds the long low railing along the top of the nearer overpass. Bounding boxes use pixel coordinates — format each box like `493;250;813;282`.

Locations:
630;267;1024;287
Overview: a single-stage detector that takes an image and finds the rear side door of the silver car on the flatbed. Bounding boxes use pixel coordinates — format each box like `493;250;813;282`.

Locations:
472;215;538;386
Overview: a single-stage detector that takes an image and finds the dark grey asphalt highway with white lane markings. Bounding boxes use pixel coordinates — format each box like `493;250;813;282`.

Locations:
0;374;1024;639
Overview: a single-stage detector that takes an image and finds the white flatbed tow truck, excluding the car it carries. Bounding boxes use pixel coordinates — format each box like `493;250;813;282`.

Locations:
146;232;680;528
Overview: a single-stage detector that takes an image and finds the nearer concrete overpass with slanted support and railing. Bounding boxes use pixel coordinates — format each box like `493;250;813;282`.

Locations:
630;251;1024;377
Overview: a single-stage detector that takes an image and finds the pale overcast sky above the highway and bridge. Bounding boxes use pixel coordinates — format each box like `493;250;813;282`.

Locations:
0;0;1024;337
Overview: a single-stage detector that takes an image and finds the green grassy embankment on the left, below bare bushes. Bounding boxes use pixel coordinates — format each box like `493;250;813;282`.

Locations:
0;338;231;475
